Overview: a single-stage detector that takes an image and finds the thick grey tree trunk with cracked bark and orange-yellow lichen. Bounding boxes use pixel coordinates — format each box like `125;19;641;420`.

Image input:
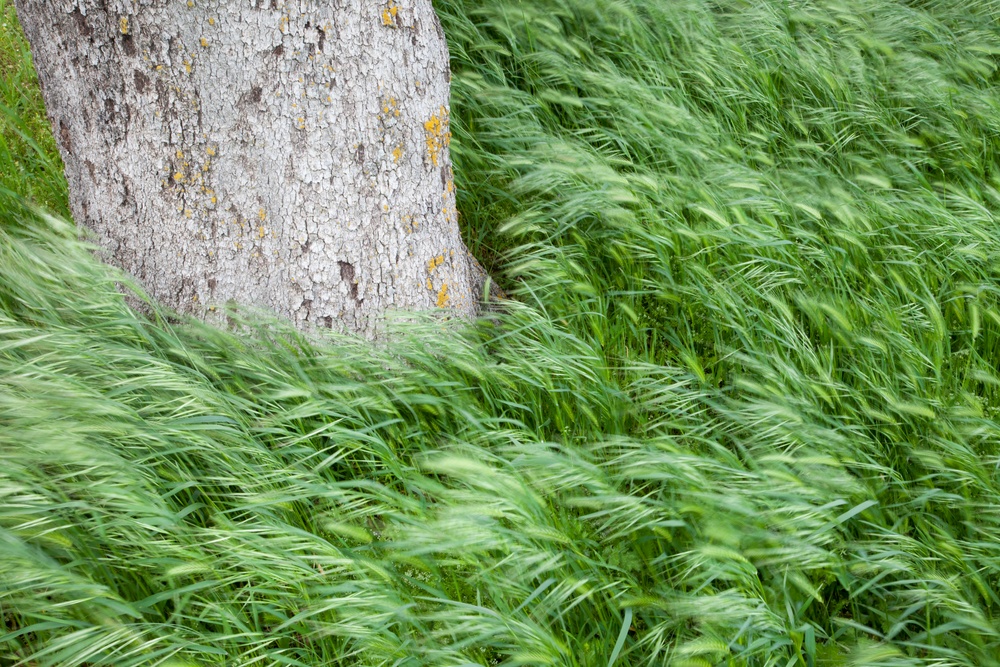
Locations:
16;0;482;336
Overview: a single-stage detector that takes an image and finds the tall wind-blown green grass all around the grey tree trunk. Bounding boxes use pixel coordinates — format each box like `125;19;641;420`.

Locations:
0;0;1000;667
